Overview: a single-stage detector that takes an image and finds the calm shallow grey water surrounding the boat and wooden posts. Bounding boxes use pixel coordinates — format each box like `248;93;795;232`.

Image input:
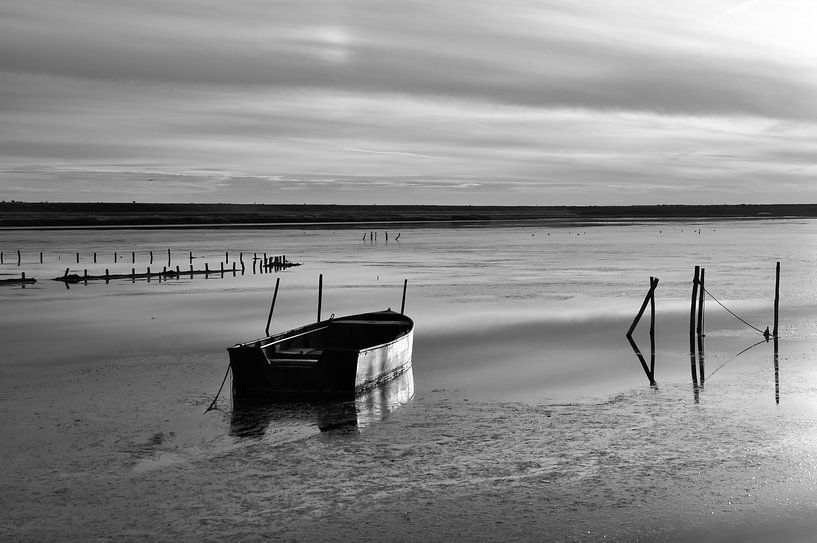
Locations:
0;221;817;540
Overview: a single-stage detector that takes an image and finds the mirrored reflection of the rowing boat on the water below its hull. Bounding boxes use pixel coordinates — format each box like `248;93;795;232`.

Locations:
230;366;414;437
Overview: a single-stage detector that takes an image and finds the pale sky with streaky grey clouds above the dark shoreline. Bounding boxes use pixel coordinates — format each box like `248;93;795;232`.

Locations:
0;0;817;205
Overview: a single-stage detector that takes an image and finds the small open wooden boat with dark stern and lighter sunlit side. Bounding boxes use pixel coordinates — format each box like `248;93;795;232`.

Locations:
227;310;414;402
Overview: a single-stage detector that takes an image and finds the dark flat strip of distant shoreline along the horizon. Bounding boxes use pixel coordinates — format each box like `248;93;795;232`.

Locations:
0;202;817;228
